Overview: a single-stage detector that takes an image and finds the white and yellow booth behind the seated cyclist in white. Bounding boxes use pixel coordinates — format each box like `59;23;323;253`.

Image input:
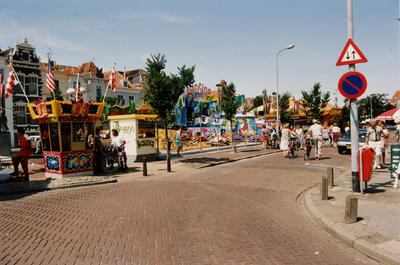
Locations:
108;104;158;163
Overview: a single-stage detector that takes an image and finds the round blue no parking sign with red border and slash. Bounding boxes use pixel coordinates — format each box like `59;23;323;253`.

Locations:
338;71;367;99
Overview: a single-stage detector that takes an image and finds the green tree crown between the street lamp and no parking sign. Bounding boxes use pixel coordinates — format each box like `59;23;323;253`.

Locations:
300;82;330;120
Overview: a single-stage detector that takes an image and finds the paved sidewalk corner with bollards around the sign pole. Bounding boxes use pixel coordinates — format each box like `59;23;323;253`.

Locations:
305;161;400;264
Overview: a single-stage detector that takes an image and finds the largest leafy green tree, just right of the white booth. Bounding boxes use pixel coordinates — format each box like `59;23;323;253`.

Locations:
144;54;195;156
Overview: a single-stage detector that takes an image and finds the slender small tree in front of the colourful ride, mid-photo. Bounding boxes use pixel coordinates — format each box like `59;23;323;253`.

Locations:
221;83;240;153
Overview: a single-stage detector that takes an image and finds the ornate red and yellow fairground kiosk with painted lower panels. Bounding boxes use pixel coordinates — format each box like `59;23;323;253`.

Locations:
28;100;104;179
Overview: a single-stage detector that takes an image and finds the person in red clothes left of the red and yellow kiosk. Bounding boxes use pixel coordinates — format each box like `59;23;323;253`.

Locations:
10;127;31;181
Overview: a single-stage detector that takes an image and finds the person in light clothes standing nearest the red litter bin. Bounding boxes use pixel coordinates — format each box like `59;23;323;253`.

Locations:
365;119;386;169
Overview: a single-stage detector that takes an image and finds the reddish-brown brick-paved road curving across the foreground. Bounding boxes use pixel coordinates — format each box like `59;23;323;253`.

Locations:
0;149;382;264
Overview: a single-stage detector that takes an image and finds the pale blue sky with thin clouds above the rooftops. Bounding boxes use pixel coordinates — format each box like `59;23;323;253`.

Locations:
0;0;400;106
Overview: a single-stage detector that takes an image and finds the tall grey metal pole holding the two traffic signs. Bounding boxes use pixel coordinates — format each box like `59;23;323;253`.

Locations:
347;0;360;192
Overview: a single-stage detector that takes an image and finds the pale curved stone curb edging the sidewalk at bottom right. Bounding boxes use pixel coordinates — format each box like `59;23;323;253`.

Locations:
305;188;400;264
